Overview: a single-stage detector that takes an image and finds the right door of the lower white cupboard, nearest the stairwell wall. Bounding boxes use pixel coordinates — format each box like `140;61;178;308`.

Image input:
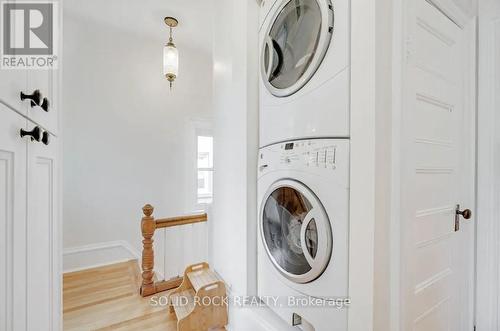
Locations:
26;131;61;331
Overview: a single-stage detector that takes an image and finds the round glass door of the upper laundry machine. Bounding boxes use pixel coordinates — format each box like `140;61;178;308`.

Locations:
261;0;333;97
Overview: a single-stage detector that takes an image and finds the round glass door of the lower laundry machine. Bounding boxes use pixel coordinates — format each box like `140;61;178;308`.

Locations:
260;180;332;283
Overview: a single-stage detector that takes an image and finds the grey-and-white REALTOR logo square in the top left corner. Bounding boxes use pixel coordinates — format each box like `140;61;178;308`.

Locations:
0;1;60;69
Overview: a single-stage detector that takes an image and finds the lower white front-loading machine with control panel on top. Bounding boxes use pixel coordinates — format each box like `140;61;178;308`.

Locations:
258;139;349;331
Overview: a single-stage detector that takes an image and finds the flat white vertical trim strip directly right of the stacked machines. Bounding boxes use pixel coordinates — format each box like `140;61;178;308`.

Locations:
348;0;378;331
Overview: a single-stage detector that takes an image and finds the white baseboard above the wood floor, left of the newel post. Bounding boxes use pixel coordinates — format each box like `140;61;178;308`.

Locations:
63;240;140;273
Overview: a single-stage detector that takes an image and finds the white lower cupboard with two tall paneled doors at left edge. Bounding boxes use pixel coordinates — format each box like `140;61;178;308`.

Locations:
0;104;61;331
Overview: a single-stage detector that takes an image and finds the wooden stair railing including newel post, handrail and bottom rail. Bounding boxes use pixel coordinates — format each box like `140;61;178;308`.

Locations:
140;204;208;297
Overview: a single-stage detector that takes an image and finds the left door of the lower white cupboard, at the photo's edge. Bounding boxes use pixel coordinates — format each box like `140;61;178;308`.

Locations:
0;104;26;331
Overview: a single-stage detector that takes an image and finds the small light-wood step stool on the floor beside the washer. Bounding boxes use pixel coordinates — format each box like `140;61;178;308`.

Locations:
169;262;228;331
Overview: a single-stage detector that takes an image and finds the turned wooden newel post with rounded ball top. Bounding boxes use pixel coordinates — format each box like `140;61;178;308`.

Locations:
141;204;156;297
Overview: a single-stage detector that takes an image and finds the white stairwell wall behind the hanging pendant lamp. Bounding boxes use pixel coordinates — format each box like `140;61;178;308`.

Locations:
63;0;212;274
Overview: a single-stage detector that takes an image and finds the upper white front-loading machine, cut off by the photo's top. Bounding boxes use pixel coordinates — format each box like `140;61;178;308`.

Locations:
259;0;350;147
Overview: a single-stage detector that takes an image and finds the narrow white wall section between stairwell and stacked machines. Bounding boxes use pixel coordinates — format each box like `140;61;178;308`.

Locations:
211;0;258;294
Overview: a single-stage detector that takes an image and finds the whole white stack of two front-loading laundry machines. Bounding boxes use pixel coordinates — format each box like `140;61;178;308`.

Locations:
258;0;350;331
